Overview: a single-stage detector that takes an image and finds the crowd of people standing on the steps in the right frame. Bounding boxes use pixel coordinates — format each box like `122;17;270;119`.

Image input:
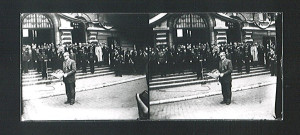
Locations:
149;43;276;79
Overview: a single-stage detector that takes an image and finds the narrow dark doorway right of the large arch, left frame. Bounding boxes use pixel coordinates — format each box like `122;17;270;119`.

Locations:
71;22;86;44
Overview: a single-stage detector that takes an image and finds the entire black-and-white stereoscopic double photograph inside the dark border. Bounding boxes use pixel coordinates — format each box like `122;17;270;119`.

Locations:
20;12;283;121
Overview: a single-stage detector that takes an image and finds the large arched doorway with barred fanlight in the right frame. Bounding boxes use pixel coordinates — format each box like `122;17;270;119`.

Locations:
175;14;210;47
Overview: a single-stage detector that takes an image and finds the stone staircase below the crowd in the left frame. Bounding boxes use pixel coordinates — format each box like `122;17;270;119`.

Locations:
22;65;114;86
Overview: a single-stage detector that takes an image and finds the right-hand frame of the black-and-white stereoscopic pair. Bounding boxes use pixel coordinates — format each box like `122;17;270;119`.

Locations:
149;12;283;120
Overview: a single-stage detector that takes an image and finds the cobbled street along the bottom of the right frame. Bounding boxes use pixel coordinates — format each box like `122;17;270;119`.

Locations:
150;84;276;121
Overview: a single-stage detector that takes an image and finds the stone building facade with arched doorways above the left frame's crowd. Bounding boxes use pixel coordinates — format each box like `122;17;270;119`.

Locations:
21;13;142;48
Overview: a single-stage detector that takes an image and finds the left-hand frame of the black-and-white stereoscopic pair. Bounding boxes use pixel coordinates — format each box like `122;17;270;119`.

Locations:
20;13;153;121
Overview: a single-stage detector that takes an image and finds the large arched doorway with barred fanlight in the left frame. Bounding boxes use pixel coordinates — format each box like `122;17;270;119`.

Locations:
22;14;54;45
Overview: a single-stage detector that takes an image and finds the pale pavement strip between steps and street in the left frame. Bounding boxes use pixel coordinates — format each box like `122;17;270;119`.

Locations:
22;75;146;101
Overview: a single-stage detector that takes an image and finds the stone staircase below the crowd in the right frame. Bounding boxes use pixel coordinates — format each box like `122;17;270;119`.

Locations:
149;66;270;90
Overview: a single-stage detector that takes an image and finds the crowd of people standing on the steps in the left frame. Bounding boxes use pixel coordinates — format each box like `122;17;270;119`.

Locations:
22;43;148;79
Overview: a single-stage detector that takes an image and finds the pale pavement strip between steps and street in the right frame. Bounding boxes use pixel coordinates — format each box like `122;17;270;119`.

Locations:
149;74;277;105
